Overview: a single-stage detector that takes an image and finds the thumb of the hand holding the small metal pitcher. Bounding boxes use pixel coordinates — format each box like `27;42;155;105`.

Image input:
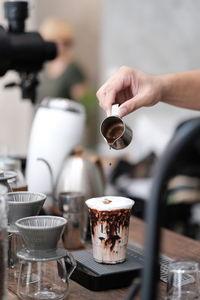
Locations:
119;95;146;118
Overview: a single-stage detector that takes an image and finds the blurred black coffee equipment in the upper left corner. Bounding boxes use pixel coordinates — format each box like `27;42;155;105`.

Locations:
0;1;57;103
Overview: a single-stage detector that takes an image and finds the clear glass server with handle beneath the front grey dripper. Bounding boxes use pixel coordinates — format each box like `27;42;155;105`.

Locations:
17;249;76;300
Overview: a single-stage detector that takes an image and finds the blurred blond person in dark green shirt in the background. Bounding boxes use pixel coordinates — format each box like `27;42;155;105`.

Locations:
38;17;97;147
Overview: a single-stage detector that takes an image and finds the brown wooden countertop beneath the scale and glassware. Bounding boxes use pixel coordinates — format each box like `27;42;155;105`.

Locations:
8;217;200;300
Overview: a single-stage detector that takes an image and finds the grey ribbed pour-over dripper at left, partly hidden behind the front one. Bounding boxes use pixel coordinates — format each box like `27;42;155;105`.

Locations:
4;192;46;232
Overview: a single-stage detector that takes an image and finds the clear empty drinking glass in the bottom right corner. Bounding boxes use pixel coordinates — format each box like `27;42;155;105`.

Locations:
166;261;200;300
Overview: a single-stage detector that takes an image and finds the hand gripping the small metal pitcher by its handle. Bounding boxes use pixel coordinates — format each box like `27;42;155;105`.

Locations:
97;66;162;117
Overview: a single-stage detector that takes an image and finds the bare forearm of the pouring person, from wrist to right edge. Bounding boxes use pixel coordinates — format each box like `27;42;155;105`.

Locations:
158;70;200;110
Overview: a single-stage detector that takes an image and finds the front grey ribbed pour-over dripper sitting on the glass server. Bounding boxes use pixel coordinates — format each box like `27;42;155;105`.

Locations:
16;216;67;259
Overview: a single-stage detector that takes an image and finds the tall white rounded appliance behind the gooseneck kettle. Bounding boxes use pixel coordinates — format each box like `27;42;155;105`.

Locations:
26;98;86;194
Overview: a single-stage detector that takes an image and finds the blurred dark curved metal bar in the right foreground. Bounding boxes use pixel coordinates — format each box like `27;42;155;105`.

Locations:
127;118;200;300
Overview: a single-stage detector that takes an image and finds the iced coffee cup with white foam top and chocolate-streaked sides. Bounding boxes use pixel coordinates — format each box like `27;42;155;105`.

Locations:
86;196;134;264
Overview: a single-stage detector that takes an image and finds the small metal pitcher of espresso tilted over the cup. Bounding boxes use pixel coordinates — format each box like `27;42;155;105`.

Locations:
100;116;133;150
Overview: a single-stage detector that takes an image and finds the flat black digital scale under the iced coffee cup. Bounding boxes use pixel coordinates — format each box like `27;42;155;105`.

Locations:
71;244;189;291
